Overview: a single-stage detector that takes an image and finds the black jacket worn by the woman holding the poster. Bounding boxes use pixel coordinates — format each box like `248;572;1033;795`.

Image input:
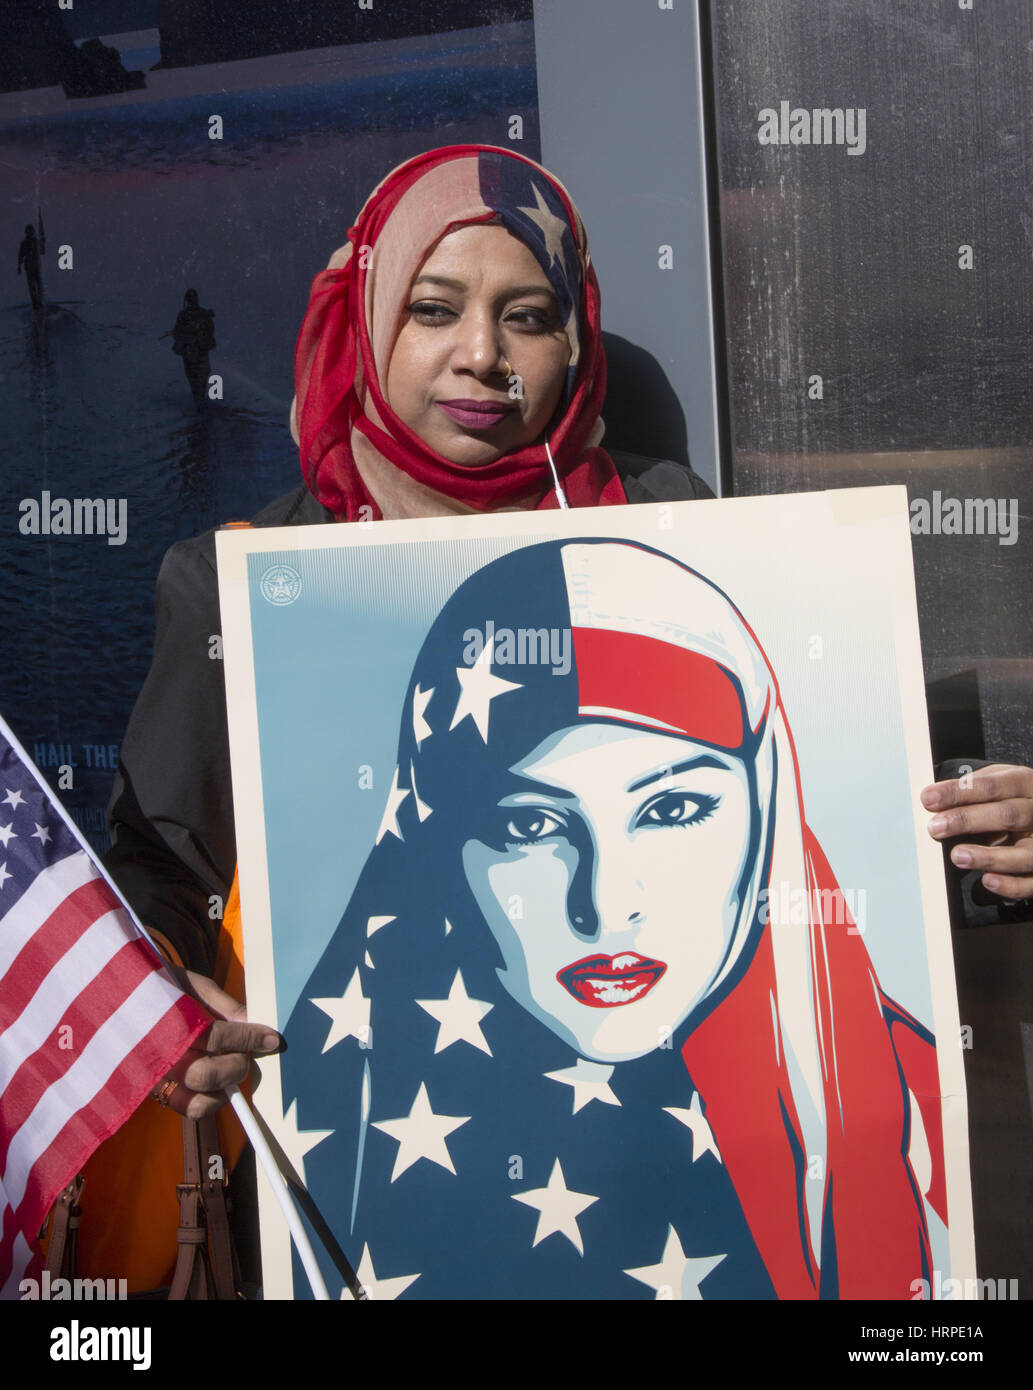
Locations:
107;449;713;974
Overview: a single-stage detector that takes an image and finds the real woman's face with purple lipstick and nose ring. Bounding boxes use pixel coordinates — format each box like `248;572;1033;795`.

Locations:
385;227;570;467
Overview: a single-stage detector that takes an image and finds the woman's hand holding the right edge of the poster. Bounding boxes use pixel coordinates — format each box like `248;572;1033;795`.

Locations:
922;763;1033;898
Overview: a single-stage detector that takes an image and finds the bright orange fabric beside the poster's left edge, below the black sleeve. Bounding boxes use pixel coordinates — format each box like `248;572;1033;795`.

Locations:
76;874;249;1293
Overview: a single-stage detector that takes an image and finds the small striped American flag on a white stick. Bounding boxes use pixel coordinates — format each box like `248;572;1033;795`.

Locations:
0;719;211;1298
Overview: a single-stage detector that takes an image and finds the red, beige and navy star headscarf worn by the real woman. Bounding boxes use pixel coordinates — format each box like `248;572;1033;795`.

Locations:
291;145;626;521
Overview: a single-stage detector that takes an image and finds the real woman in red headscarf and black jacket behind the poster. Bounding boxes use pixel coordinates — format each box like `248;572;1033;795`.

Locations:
102;146;1033;1289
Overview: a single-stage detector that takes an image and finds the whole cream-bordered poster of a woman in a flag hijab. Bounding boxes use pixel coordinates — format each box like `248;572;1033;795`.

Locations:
218;488;975;1298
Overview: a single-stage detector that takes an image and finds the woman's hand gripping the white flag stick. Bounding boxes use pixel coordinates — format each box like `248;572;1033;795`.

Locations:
154;966;284;1120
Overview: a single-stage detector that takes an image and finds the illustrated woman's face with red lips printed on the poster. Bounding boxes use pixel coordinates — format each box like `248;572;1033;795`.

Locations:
463;723;751;1062
